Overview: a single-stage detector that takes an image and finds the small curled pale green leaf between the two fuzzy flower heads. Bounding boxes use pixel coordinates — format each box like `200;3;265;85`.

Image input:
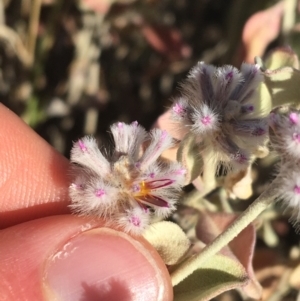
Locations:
177;133;203;185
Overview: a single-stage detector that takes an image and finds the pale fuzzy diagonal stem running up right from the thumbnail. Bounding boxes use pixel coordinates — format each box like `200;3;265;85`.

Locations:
171;179;278;286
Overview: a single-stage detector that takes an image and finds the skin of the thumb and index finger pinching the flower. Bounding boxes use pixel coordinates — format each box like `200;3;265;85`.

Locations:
0;105;173;301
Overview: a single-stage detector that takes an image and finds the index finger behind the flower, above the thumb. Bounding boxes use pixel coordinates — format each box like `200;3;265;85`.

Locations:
0;104;69;228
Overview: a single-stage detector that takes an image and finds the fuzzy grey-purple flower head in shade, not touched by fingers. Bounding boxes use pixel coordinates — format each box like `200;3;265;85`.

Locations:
172;62;267;168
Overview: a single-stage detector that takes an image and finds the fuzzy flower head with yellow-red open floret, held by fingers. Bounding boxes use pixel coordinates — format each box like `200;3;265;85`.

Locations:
69;122;184;234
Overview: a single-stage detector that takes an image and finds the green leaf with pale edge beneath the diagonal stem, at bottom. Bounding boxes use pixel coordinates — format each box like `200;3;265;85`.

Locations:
174;254;249;301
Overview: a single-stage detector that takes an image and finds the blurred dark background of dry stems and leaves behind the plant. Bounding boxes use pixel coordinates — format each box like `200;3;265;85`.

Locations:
0;0;300;301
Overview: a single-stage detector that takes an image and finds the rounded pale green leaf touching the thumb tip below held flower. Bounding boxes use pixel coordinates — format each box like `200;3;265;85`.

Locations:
143;221;191;265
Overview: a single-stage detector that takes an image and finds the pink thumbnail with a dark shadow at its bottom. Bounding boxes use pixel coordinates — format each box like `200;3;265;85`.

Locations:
44;228;170;301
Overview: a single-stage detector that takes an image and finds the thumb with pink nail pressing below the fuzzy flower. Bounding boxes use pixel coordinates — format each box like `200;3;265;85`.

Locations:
0;215;173;301
